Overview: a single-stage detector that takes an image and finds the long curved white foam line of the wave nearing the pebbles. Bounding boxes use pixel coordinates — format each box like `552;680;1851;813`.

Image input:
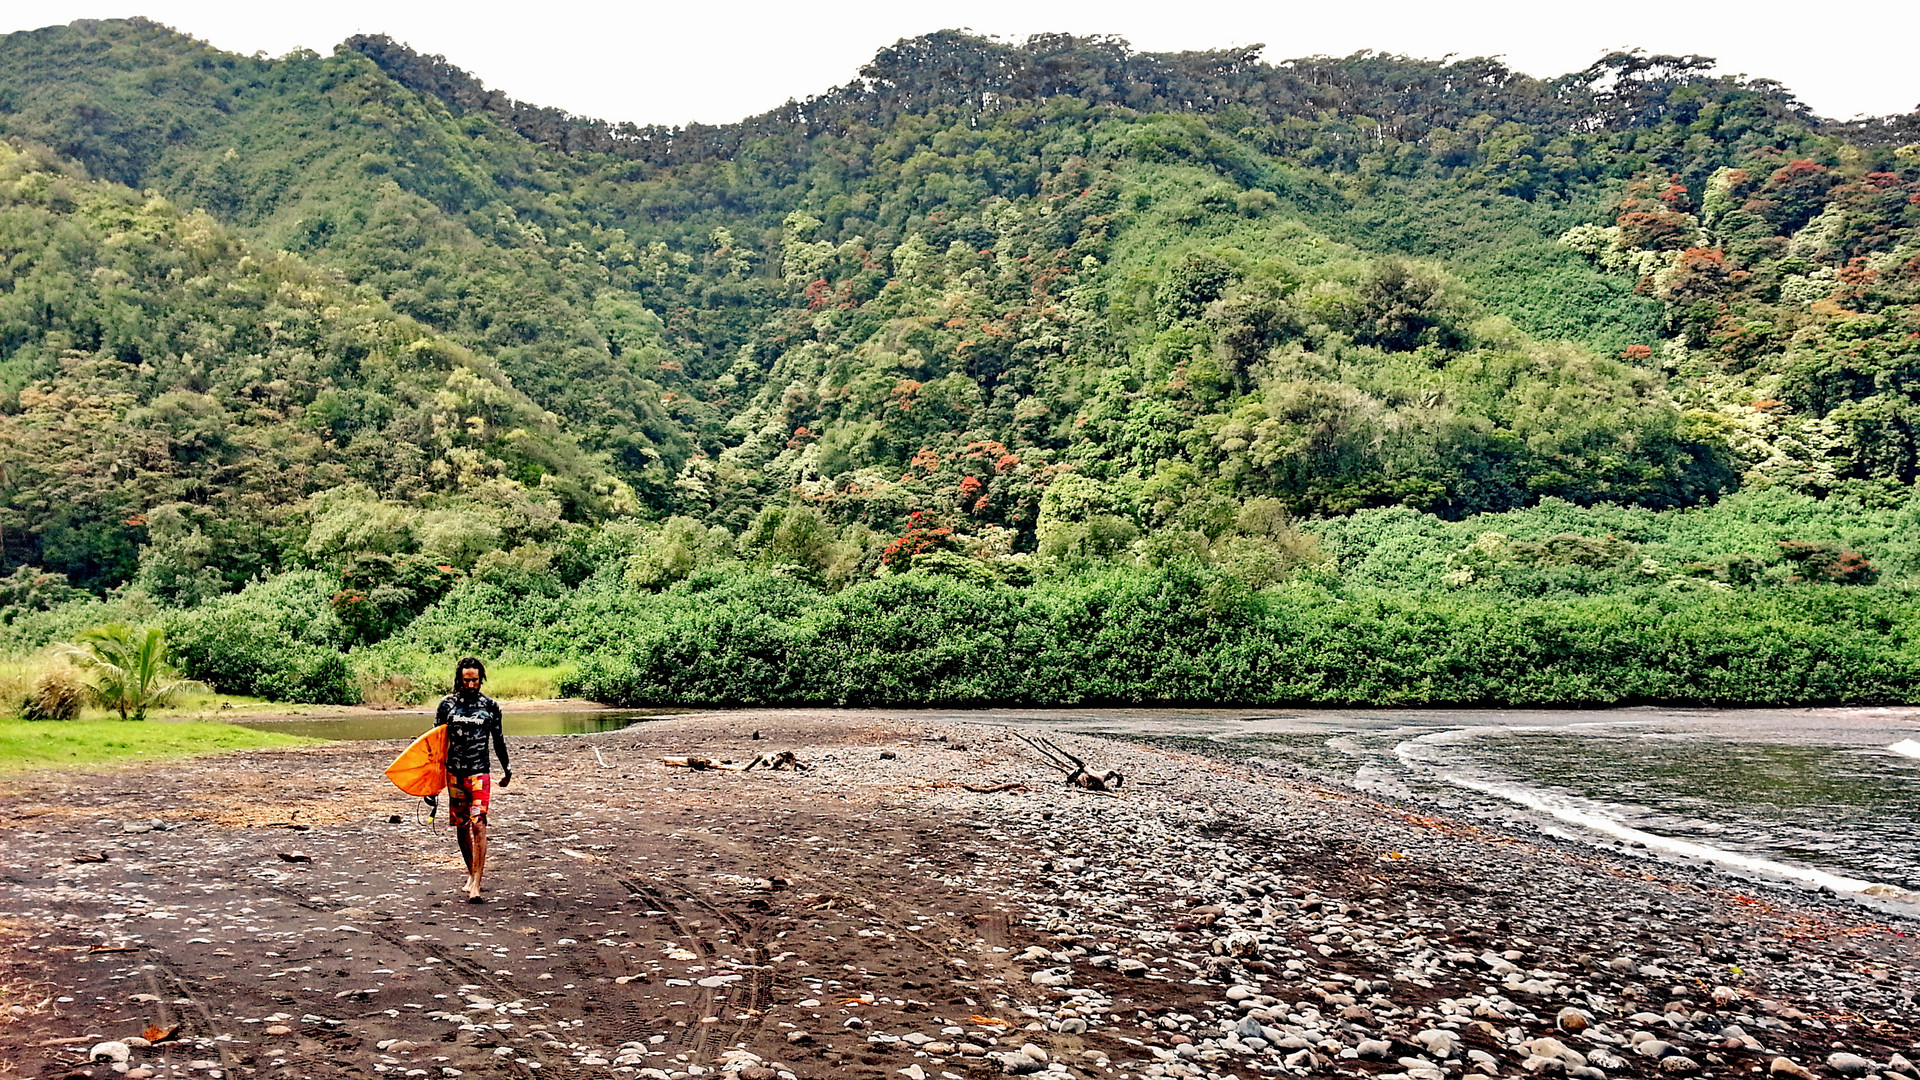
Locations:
1394;724;1920;903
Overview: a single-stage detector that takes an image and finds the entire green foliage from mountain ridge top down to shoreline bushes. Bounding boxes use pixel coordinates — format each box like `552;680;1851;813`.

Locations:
0;19;1920;707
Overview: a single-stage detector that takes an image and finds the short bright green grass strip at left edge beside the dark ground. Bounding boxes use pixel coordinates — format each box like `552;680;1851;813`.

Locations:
0;721;324;773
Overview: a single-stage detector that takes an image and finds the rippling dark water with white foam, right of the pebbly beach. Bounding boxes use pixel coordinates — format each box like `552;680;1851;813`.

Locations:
1006;709;1920;913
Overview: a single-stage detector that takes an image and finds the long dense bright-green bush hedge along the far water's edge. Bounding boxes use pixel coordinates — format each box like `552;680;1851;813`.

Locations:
566;563;1920;707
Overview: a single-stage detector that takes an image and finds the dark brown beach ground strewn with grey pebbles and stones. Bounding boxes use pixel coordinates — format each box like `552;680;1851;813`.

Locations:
0;711;1920;1080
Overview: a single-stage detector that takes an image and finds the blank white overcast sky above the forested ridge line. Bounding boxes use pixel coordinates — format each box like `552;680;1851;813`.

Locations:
15;0;1920;123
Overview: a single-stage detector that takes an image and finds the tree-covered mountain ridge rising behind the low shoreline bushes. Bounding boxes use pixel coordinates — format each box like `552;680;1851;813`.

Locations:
0;21;1920;707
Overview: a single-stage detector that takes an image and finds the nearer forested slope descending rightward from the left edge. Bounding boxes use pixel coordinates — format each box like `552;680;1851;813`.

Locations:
0;136;630;588
